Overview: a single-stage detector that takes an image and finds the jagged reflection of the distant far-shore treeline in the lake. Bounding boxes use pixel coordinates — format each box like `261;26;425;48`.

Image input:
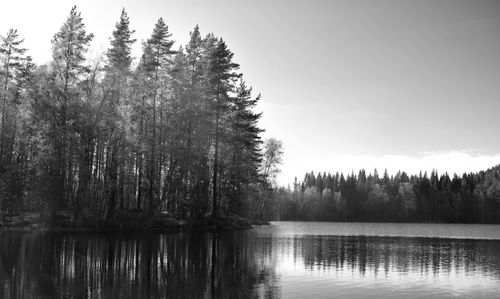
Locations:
279;236;500;279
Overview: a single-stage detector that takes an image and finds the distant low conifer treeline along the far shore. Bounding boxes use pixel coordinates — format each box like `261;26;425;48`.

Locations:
273;165;500;223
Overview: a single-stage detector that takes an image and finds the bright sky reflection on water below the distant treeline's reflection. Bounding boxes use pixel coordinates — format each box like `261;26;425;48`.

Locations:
276;255;500;298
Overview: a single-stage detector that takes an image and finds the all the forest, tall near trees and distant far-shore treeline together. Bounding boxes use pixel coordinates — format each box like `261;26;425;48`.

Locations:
0;7;500;229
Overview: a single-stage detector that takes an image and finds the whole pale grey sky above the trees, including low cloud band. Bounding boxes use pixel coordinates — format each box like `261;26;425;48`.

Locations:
0;0;500;185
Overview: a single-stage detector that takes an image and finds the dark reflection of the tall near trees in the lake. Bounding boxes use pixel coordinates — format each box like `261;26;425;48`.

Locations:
0;232;276;298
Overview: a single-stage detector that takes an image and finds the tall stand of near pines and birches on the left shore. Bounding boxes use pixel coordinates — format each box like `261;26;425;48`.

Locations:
0;7;282;222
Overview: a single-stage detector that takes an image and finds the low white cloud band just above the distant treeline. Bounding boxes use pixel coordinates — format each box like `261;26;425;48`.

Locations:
278;149;500;186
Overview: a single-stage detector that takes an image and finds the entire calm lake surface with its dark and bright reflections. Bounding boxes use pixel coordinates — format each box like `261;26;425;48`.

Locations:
0;222;500;298
